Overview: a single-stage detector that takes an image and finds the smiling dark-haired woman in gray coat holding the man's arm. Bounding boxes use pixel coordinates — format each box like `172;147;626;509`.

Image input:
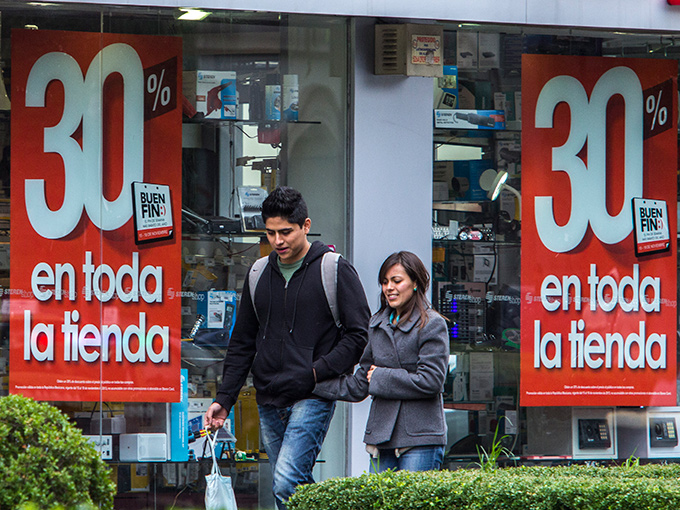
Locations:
314;251;449;472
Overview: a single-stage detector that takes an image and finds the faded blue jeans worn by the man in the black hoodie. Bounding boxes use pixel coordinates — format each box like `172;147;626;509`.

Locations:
258;399;335;510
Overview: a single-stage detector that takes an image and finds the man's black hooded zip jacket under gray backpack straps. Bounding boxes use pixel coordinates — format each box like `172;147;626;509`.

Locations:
215;241;370;410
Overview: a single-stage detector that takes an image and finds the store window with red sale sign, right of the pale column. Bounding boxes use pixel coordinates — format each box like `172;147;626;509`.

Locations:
432;24;678;468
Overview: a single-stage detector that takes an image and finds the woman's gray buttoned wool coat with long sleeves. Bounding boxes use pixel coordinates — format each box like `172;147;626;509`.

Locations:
314;308;449;448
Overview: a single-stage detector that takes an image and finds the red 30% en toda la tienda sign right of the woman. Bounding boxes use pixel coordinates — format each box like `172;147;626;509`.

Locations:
520;55;678;406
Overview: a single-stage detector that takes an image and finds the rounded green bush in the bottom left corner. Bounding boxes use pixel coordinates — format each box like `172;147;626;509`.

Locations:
0;395;116;509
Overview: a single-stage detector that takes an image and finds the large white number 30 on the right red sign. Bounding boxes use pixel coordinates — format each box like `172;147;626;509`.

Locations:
534;67;644;253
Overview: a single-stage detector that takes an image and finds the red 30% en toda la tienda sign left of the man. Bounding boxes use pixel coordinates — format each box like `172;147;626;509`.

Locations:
6;30;182;402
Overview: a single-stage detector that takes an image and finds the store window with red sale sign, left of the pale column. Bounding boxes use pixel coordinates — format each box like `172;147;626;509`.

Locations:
0;2;348;508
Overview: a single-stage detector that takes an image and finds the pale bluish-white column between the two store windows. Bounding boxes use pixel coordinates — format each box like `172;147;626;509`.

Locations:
347;19;433;476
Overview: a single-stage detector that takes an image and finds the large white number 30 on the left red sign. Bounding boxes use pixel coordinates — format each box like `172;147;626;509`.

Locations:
24;43;144;239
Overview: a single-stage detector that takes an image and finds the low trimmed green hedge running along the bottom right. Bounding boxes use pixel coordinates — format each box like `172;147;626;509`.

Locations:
288;464;680;510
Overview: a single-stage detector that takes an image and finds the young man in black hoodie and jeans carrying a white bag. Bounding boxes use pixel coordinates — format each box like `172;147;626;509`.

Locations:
204;187;370;509
